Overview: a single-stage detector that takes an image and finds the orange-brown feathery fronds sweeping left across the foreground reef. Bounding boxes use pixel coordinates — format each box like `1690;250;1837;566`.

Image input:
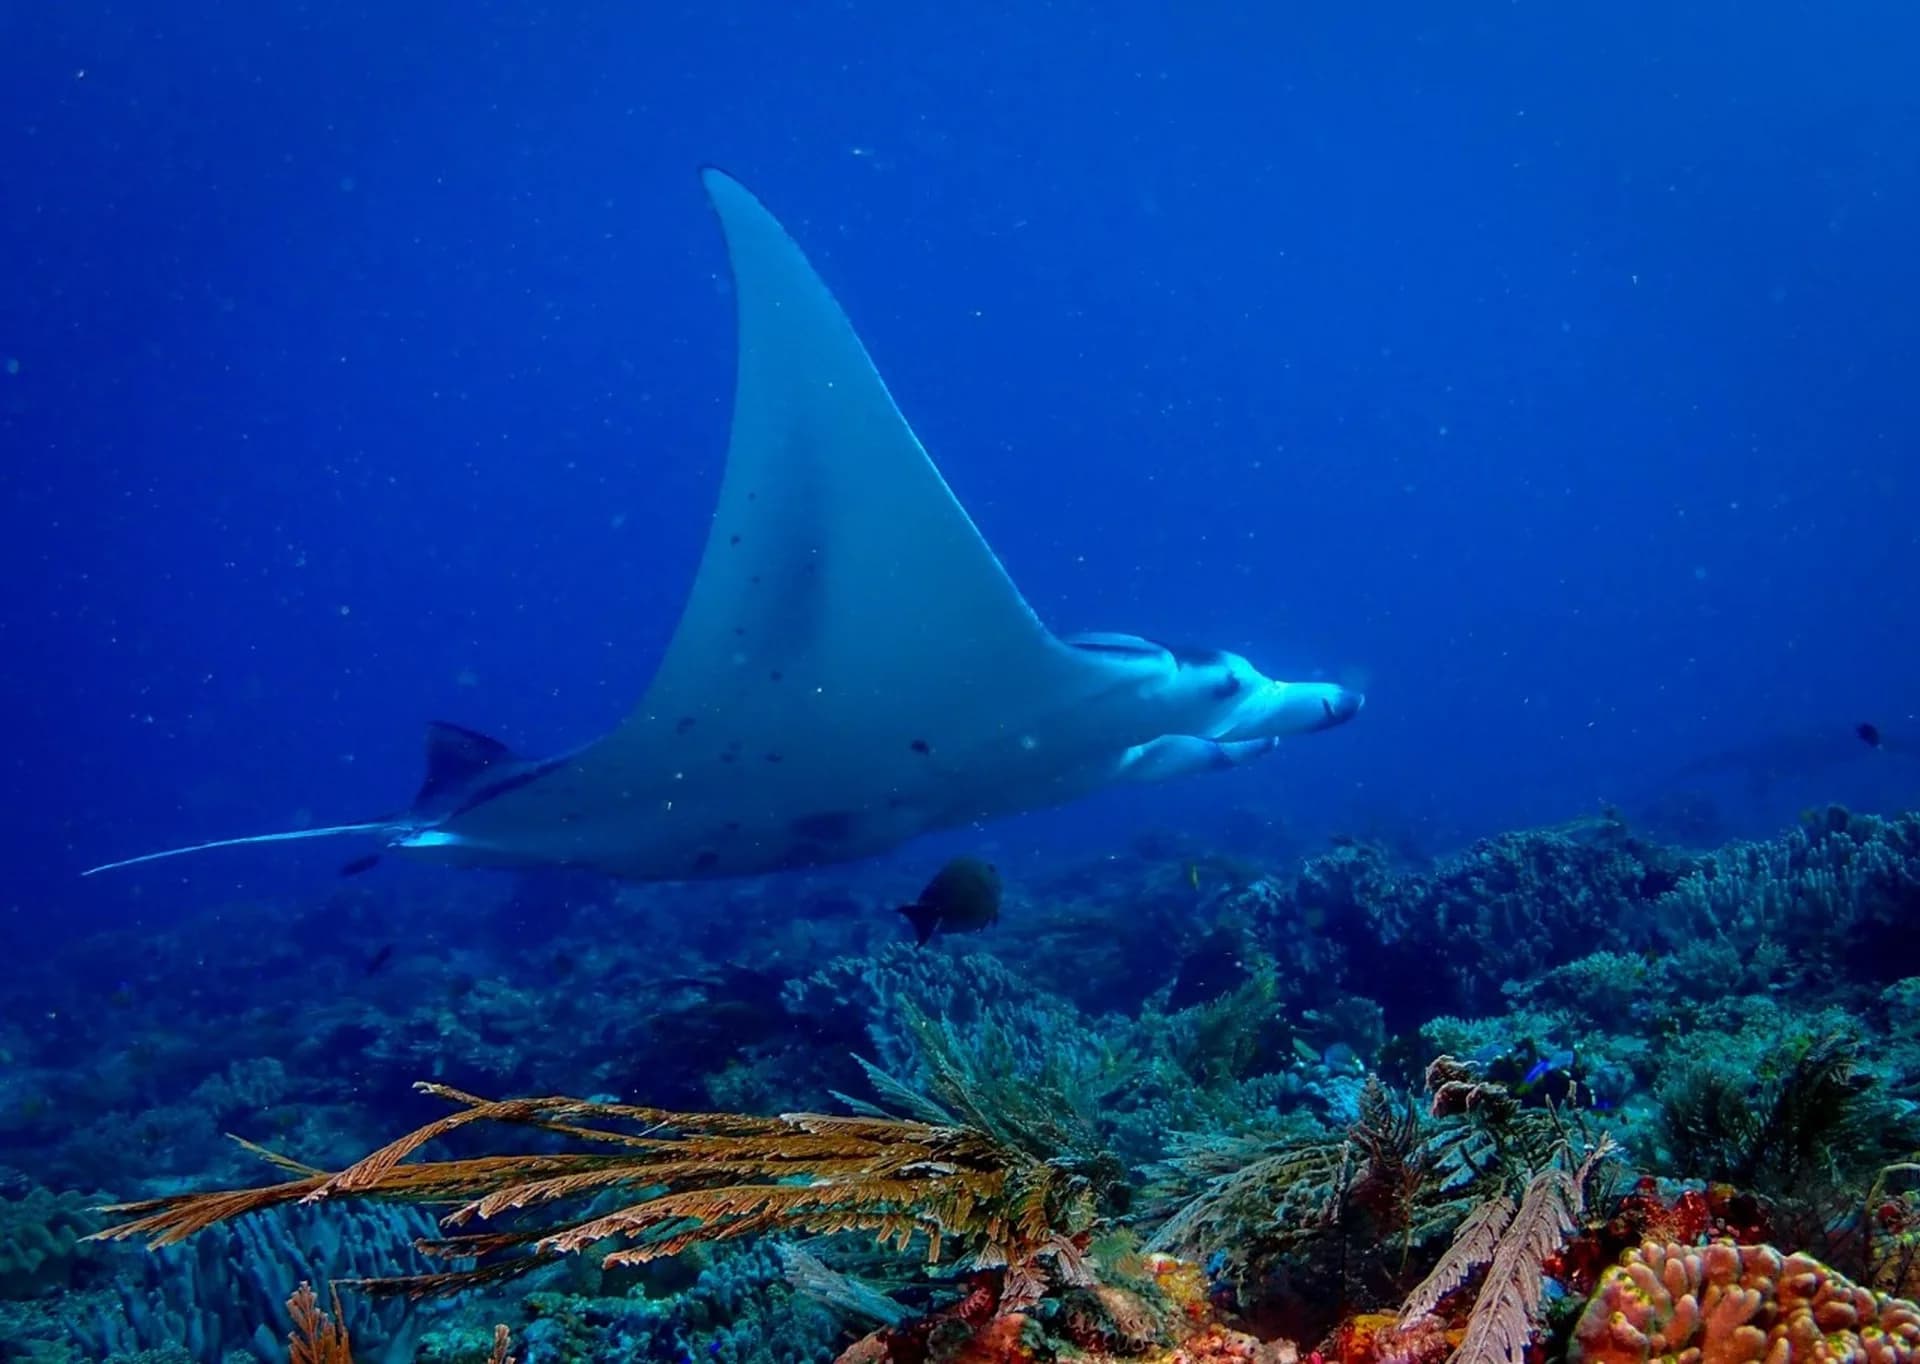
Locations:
96;1084;1094;1303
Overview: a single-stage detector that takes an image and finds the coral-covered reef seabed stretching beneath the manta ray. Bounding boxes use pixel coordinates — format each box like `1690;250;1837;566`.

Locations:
0;809;1920;1364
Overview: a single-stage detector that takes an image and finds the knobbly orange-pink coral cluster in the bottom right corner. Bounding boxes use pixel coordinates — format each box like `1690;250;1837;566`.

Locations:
1569;1241;1920;1364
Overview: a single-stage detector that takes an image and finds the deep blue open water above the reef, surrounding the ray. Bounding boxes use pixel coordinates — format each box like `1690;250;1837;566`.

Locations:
0;0;1920;932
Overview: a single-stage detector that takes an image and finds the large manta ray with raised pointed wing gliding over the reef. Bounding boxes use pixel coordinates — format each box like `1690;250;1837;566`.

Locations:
86;169;1363;880
